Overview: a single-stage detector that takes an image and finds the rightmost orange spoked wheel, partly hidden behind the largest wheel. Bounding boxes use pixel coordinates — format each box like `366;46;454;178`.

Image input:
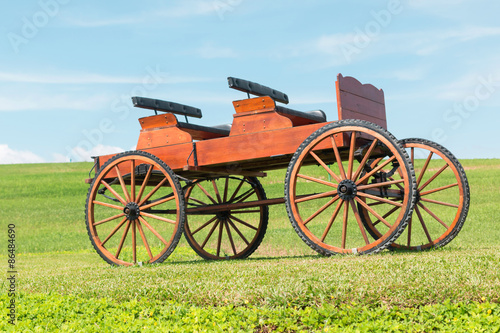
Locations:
362;138;470;250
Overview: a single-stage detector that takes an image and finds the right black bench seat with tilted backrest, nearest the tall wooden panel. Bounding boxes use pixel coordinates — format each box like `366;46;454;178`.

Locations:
227;77;326;126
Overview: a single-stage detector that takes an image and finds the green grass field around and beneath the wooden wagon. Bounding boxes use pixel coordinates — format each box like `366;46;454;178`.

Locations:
0;159;500;332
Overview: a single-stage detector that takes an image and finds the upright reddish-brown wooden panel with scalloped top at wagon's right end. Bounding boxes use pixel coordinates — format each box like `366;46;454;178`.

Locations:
335;74;387;129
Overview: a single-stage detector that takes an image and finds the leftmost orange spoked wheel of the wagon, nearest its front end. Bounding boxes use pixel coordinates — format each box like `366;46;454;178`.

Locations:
85;151;185;266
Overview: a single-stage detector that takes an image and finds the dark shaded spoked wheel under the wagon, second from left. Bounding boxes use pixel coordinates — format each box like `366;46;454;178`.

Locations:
185;177;269;259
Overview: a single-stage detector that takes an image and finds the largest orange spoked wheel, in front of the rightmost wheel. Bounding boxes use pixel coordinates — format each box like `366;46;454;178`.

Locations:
285;120;416;255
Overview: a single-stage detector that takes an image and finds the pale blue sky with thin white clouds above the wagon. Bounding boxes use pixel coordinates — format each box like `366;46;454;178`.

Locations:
0;0;500;164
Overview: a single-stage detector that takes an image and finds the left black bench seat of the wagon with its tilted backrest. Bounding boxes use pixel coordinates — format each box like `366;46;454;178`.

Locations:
132;97;231;140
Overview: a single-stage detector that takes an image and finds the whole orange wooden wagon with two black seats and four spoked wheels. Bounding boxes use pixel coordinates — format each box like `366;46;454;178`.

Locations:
86;74;469;265
